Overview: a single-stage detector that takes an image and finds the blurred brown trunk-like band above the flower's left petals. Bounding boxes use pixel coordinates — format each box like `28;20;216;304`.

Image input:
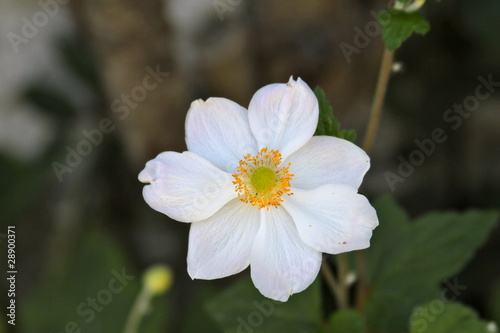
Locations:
72;0;189;169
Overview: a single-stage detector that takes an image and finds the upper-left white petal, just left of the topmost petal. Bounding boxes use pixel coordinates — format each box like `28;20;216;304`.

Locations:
186;98;257;173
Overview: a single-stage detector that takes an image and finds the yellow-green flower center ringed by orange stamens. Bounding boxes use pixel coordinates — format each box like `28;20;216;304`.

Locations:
233;148;293;209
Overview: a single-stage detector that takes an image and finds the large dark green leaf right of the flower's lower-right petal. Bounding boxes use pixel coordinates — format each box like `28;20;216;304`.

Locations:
366;198;498;333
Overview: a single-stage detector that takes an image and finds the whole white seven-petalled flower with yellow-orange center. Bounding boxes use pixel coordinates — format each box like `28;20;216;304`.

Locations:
139;78;378;301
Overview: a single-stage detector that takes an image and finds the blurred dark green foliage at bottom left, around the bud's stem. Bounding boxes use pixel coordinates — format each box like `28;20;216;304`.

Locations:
20;233;168;333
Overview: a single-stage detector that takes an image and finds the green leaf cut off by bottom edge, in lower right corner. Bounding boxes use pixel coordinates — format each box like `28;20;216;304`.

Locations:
410;301;488;333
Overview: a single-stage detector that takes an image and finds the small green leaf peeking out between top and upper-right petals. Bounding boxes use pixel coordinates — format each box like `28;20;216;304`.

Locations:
314;87;357;143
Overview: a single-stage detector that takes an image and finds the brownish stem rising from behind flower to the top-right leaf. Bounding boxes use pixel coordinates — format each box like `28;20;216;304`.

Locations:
363;49;394;153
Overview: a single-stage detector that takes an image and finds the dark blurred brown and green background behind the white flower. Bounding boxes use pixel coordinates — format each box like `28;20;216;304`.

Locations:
0;0;500;333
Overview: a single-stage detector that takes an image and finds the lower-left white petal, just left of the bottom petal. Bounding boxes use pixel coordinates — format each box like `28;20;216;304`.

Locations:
187;199;260;280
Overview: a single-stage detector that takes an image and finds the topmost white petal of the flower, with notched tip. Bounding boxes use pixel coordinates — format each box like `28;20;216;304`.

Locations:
248;78;319;158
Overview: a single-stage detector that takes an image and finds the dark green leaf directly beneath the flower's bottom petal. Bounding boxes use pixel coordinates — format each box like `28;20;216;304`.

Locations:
206;277;321;333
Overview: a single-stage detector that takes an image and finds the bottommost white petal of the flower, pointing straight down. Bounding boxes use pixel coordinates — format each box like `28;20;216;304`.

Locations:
250;208;321;302
